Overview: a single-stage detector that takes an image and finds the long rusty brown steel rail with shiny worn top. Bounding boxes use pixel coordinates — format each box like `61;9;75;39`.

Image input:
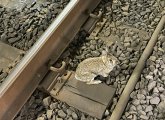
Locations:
0;0;101;120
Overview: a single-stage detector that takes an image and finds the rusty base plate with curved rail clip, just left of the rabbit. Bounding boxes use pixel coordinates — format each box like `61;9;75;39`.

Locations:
38;61;72;96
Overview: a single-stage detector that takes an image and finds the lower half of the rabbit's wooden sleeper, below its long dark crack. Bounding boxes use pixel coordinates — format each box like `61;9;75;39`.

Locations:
55;87;107;119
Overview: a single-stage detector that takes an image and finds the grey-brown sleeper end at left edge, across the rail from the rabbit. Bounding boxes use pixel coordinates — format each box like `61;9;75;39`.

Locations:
0;42;23;69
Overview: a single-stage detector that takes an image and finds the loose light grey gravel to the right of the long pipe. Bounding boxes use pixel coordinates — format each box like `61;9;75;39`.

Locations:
122;29;165;120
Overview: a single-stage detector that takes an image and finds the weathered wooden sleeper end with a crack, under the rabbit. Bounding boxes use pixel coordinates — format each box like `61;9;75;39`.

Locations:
51;72;115;119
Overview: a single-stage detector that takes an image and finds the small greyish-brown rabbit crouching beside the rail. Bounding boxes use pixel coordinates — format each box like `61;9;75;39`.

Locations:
75;47;119;84
